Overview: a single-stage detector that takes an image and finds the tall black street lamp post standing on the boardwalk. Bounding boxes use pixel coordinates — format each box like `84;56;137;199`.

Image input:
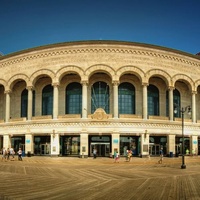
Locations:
174;106;191;169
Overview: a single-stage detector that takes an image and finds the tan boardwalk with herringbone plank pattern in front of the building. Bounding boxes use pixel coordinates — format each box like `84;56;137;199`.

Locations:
0;156;200;200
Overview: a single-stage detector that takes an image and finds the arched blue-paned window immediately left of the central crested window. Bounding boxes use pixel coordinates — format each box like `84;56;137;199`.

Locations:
65;83;82;114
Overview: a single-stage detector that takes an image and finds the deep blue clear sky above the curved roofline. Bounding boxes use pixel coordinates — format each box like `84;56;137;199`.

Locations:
0;0;200;55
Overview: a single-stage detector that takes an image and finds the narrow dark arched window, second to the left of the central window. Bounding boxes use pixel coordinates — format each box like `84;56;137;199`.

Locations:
42;85;53;115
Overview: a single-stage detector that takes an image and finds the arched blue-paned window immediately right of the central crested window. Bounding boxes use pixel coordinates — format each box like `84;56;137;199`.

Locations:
118;82;135;114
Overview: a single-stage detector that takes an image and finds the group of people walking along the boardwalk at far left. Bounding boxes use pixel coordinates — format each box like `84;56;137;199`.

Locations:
2;147;22;161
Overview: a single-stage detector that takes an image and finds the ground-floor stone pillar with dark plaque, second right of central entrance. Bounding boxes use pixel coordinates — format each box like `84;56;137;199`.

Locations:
140;130;149;158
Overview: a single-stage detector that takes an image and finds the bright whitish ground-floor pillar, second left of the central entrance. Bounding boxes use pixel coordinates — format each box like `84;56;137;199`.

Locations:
51;130;60;156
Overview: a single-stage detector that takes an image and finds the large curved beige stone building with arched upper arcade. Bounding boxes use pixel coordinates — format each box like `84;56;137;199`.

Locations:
0;41;200;157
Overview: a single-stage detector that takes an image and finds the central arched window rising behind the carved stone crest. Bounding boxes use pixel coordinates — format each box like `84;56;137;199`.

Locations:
91;81;110;113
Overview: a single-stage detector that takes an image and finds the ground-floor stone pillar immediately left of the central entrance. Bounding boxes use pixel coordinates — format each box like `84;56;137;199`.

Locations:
80;131;89;158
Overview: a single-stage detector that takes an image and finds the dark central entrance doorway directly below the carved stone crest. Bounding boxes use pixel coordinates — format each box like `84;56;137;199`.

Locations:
90;143;110;157
